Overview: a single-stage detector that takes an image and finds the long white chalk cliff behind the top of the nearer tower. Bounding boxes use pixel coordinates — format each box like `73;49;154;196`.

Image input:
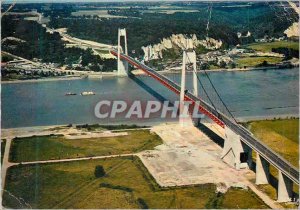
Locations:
142;34;223;61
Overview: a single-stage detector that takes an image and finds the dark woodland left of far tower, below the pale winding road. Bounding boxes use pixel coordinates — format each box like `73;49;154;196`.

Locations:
1;15;116;71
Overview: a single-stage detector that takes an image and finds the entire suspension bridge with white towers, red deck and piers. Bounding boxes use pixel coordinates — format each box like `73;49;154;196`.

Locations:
110;29;299;202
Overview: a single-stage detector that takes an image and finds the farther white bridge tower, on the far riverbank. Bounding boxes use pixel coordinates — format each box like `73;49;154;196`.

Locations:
118;28;128;76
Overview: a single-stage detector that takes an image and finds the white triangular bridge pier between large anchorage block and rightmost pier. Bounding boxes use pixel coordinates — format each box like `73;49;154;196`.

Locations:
255;153;270;185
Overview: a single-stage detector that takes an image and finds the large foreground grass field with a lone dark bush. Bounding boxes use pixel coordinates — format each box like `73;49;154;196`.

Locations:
3;157;268;209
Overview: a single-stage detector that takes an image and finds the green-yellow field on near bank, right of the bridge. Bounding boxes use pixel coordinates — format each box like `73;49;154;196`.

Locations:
249;119;299;168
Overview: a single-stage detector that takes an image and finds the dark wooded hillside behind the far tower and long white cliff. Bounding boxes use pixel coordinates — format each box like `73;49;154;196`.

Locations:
50;3;298;57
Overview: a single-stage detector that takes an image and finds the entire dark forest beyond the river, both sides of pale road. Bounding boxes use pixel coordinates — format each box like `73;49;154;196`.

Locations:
1;2;298;71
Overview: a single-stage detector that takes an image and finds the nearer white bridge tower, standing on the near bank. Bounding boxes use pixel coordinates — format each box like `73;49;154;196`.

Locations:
179;50;198;126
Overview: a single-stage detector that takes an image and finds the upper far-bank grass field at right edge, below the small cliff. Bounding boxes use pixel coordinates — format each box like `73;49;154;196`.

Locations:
247;41;299;52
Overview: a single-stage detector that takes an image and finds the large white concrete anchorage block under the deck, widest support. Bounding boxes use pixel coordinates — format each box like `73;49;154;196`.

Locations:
221;126;252;169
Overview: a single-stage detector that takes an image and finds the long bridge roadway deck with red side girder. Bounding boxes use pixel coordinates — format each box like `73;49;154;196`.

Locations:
111;50;299;185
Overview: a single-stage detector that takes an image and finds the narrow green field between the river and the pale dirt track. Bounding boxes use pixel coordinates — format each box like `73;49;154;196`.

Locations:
10;130;162;162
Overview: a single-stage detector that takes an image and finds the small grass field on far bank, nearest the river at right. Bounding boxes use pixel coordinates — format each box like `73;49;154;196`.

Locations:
235;57;282;68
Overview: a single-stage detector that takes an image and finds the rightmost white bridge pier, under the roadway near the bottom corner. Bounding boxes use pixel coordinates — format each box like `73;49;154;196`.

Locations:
277;171;293;202
